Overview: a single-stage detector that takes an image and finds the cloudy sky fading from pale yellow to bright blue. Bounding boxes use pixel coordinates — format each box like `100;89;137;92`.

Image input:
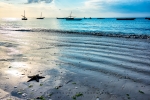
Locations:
0;0;150;18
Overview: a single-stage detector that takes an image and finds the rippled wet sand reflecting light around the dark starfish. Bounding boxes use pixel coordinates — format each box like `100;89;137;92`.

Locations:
0;31;150;100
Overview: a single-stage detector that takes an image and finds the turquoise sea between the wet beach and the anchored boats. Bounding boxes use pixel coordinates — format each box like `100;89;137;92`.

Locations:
0;18;150;35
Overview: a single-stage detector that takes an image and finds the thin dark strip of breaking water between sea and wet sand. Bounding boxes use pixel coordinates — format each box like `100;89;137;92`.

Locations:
13;29;150;39
